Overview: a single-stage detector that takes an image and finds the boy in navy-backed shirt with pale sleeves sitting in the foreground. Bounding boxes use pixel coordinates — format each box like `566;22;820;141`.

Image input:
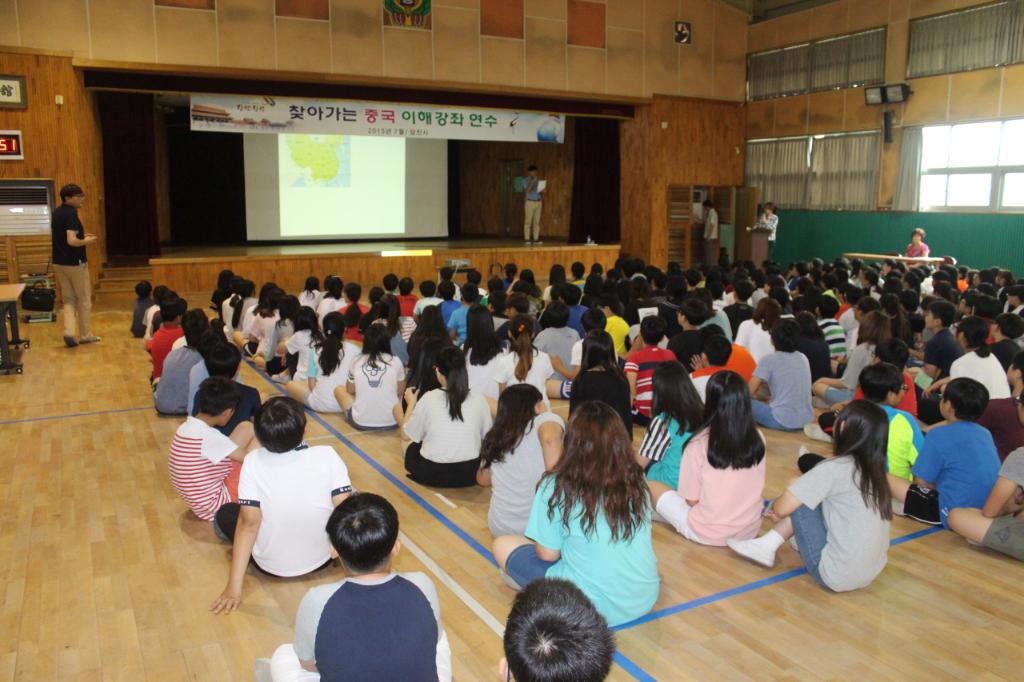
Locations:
257;493;452;682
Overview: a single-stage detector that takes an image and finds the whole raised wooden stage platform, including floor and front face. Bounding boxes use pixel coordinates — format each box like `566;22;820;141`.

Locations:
150;238;620;296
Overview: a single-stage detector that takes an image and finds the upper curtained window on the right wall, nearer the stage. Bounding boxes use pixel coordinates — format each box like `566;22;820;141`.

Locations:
748;29;886;99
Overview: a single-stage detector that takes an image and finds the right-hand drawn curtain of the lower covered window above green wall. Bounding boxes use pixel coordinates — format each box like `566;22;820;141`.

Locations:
807;133;882;210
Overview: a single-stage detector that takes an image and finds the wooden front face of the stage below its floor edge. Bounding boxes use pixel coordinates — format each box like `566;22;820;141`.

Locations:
151;245;620;296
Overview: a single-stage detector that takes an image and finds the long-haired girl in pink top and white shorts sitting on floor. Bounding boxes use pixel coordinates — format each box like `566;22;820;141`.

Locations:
647;371;765;547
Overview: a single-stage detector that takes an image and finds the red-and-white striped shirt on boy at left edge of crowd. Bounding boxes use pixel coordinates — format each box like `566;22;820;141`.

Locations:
167;417;238;521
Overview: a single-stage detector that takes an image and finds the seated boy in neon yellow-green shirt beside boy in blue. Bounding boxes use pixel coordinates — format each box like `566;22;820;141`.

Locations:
797;363;925;482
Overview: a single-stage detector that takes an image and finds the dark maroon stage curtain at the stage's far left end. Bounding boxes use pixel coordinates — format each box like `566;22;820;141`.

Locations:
96;92;160;256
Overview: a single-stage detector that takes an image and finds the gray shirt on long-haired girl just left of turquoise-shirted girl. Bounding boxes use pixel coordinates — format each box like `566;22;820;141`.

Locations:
487;412;565;537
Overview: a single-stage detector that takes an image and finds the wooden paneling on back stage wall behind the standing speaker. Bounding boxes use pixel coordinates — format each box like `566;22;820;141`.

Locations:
459;117;575;239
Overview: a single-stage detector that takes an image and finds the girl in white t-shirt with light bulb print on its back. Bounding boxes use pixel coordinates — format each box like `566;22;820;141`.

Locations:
334;325;406;431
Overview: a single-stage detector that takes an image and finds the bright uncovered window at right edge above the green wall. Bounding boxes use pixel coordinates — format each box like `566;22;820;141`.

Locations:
920;119;1024;211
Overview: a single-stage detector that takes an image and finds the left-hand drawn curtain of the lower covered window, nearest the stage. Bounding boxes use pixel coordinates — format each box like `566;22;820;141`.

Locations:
746;137;810;208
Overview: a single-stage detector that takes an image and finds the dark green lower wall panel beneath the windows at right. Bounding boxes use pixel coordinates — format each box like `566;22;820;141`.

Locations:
775;211;1024;272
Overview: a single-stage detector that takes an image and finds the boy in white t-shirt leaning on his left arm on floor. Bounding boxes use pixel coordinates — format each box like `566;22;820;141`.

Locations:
210;396;352;613
